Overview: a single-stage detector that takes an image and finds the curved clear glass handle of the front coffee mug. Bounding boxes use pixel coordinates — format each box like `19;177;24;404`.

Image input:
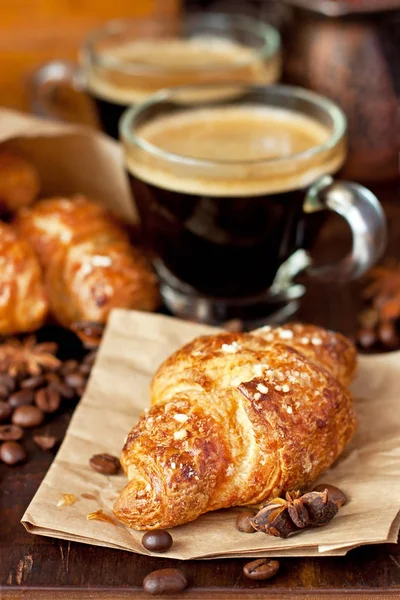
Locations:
303;175;387;282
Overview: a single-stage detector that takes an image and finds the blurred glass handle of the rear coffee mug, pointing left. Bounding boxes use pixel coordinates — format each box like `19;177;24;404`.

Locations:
30;60;98;127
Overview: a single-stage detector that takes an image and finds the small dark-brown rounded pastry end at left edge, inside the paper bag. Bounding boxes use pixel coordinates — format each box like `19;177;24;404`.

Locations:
0;150;40;213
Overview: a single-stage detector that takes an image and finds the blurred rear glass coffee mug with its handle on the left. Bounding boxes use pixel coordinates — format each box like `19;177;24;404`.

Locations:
32;13;281;138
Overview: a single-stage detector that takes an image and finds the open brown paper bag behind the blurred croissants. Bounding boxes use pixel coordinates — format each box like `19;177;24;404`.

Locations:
0;108;137;222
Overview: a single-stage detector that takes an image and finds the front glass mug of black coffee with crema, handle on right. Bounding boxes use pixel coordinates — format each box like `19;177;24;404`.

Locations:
120;85;386;323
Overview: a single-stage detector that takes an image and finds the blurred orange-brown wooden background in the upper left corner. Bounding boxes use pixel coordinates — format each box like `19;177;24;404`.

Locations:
0;0;180;110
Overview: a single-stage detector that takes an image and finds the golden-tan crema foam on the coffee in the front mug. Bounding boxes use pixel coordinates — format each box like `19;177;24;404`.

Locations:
125;104;345;197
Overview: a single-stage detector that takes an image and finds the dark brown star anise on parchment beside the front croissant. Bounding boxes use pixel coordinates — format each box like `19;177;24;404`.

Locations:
250;490;339;538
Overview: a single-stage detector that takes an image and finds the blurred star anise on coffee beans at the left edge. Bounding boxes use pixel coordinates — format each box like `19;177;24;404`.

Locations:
0;335;61;377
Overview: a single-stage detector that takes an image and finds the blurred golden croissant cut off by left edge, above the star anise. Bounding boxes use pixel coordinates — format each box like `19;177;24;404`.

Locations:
0;223;48;335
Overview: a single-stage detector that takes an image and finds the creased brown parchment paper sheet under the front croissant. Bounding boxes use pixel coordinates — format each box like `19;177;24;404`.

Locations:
22;310;400;559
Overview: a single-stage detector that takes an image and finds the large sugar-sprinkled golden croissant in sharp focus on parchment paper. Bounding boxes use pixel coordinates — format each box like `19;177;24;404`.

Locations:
114;324;356;529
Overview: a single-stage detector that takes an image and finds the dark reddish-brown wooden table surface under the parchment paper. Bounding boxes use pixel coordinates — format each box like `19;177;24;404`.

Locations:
0;184;400;600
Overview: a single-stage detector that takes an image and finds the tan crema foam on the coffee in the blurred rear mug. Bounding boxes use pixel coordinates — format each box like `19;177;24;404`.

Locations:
84;36;280;105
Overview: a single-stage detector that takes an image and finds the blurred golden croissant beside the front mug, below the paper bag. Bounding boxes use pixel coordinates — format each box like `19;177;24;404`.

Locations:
16;196;158;326
